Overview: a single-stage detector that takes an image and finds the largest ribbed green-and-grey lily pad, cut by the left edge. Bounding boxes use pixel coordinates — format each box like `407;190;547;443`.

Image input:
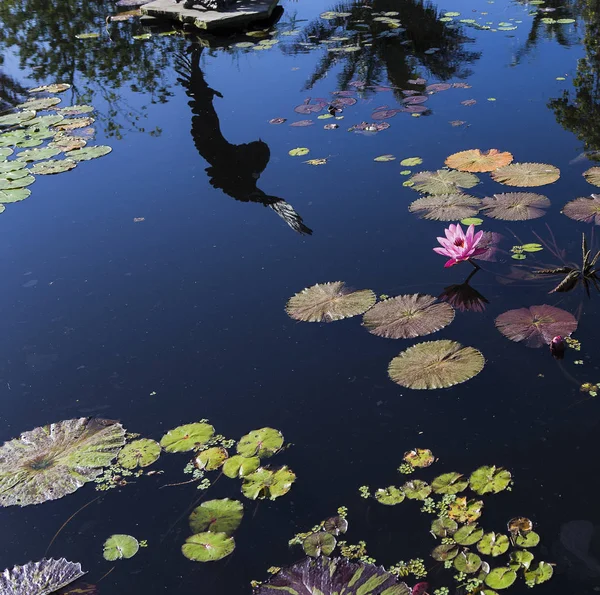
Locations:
0;417;125;506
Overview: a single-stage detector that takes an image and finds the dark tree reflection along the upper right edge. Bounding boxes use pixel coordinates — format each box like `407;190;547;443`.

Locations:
548;0;600;160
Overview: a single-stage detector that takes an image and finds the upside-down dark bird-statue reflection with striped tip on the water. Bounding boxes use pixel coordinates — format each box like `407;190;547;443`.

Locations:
177;45;312;235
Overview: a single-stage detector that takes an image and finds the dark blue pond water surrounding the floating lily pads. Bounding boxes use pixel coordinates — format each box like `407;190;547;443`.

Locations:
0;0;600;595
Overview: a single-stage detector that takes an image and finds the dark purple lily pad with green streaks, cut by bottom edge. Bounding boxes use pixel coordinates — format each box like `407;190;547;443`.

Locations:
254;557;411;595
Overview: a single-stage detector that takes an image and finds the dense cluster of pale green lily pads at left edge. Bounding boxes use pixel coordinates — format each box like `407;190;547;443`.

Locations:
0;83;112;212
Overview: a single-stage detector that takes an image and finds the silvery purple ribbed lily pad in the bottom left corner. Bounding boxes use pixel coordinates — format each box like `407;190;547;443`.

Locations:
0;558;85;595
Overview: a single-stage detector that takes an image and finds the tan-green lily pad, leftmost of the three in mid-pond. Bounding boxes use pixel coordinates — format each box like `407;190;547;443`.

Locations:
285;281;377;322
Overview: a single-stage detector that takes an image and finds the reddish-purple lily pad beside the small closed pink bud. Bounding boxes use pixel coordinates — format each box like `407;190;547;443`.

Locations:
495;304;577;347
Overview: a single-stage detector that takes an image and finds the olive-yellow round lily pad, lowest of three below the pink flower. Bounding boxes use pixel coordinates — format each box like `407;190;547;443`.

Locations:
388;340;485;389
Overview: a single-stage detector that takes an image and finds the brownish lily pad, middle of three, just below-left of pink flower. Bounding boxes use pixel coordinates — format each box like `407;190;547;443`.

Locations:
363;293;454;339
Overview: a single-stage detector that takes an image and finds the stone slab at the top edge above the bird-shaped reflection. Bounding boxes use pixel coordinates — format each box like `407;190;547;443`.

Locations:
141;0;279;31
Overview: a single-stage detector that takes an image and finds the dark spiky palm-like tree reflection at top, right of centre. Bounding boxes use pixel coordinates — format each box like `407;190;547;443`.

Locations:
284;0;480;98
